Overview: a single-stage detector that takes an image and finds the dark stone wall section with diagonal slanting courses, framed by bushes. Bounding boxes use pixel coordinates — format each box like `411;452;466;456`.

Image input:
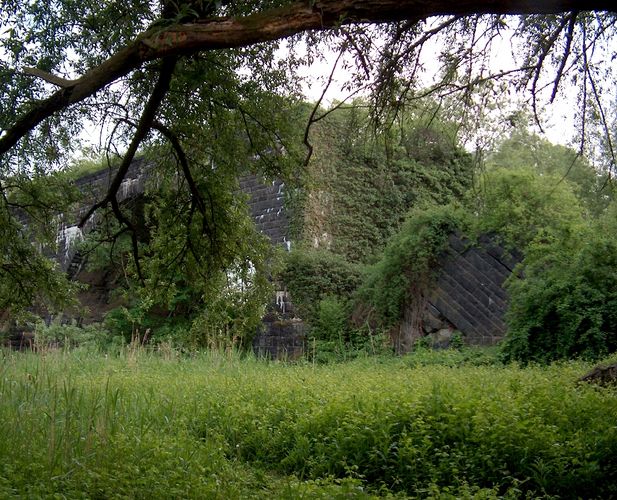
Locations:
400;234;521;347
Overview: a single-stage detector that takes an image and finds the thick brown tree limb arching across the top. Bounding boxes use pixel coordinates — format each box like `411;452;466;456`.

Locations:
0;0;617;155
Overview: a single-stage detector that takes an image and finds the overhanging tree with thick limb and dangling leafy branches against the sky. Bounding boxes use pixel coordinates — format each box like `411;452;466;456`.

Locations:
0;0;617;314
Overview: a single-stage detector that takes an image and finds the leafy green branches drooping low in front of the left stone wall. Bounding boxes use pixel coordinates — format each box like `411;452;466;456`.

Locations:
74;160;276;348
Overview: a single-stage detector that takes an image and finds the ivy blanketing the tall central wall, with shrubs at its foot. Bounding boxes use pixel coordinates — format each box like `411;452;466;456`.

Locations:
282;100;473;359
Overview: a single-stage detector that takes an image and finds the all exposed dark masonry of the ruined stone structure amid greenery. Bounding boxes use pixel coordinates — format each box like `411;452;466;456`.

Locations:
10;160;520;359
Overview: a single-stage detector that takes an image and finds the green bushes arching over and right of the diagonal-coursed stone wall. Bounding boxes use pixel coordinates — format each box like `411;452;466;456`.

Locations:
348;158;600;361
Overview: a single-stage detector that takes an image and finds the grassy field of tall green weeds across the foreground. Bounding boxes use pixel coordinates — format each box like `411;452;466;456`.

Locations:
0;351;617;499
